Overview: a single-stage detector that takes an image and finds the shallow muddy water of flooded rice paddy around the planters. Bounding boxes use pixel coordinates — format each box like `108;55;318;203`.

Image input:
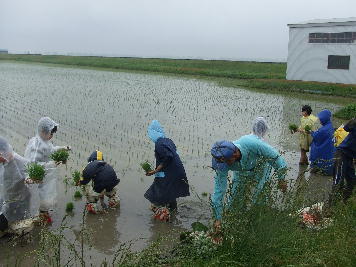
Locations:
0;63;344;263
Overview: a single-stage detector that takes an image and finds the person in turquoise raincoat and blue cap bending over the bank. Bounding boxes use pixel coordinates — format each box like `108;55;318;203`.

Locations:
211;120;287;229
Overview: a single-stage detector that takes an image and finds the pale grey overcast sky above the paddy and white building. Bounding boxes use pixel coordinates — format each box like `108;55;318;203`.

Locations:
0;0;356;60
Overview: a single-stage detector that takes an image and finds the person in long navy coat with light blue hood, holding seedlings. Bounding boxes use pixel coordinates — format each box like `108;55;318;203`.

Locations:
145;120;190;221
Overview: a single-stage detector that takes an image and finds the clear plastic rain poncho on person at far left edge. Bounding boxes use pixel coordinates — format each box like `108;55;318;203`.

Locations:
0;137;31;223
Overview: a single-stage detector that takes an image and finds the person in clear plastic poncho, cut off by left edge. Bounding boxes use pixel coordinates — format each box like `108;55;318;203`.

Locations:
0;137;33;237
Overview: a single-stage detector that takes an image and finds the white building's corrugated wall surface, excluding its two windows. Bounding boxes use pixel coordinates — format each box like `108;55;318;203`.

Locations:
287;25;356;84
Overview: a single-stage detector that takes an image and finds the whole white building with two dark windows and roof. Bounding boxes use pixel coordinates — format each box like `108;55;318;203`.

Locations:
287;18;356;84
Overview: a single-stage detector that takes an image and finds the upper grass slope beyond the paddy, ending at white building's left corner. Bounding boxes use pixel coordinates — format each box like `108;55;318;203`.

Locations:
0;55;286;79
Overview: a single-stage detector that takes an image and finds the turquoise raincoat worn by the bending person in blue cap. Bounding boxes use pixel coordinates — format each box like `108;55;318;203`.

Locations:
211;134;287;220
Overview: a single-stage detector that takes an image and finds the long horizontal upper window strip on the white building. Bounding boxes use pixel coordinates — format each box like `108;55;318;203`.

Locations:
309;32;356;44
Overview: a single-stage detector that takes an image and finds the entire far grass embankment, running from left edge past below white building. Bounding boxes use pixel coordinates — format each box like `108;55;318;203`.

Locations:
0;54;356;103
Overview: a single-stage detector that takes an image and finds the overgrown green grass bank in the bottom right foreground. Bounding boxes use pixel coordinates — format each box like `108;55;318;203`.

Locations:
122;188;356;267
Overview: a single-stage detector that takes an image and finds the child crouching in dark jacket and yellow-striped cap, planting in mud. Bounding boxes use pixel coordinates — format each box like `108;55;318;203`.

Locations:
77;150;120;214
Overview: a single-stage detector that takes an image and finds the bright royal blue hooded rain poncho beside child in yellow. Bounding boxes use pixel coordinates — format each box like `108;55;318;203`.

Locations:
310;109;335;175
